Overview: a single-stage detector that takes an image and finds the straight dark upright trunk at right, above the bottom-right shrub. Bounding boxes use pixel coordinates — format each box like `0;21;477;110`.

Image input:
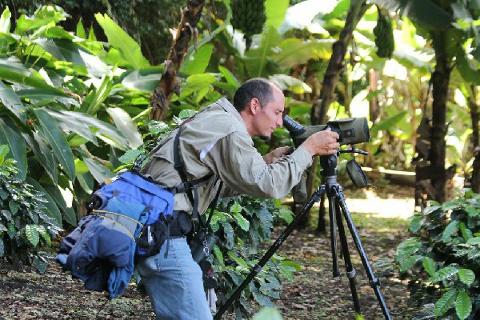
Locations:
428;31;451;202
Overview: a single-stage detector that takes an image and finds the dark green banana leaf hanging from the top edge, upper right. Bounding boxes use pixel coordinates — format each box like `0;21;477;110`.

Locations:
372;0;453;30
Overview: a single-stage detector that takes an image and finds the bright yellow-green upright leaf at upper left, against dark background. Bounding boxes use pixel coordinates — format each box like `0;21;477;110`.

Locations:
95;13;150;69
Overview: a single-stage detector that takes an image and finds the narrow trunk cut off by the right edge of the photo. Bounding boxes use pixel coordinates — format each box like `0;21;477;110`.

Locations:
468;85;480;193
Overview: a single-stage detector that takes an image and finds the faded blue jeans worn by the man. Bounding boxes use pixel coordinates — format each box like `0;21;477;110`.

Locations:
137;237;212;320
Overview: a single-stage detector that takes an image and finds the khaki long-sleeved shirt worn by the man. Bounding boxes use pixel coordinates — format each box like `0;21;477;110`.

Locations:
142;98;312;213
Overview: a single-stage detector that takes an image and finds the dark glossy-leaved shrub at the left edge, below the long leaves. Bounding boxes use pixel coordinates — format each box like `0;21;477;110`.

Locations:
0;145;60;272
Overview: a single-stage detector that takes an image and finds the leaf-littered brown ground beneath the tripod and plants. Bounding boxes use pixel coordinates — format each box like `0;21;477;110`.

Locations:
0;182;415;320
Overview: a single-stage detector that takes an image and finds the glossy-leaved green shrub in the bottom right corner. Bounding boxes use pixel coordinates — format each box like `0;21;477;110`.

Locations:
395;191;480;319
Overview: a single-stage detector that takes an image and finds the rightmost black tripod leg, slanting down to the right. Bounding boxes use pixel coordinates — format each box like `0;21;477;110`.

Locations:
335;187;392;320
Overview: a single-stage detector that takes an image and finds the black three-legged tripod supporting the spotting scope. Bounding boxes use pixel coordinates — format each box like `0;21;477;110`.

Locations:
214;155;392;320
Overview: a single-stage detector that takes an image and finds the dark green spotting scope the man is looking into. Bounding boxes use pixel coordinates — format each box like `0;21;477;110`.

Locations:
283;115;370;146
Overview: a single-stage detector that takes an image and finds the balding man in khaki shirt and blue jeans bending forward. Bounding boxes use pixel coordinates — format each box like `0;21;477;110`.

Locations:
138;78;339;320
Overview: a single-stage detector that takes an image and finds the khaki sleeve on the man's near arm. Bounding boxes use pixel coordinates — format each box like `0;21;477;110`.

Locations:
204;132;312;198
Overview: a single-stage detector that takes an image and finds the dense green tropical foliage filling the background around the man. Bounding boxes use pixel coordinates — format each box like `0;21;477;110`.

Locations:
0;0;480;319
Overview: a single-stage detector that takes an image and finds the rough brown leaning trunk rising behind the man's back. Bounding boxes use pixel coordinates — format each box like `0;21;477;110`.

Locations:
150;0;205;120
